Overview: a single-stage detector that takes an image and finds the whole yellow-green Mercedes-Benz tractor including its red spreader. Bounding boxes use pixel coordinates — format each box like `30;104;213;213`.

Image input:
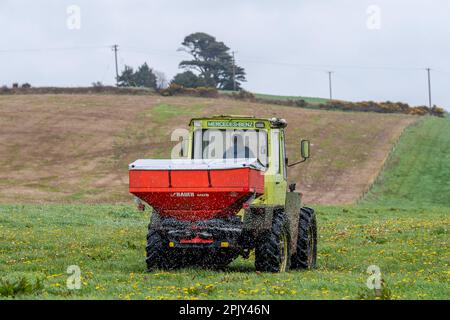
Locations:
129;116;317;272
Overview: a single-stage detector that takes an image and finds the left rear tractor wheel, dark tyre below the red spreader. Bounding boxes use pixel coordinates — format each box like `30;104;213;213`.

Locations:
145;230;176;272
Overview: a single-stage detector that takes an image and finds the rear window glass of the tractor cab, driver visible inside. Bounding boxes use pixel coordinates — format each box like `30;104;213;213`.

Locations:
193;129;268;167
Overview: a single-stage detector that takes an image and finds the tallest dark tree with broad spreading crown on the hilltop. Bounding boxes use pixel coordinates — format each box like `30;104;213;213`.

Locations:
180;32;246;90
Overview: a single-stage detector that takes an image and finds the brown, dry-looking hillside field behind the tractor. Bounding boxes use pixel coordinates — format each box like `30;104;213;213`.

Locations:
0;94;417;204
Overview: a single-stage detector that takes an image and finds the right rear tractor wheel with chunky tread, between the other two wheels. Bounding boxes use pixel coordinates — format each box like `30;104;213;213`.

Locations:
255;213;291;272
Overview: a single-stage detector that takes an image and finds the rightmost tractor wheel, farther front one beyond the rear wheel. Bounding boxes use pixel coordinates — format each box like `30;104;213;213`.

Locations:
291;208;317;269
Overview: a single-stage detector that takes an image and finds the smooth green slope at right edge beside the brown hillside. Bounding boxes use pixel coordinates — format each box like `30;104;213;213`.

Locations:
363;116;450;206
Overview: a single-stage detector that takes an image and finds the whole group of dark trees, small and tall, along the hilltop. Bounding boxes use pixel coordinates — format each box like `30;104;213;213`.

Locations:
113;32;246;90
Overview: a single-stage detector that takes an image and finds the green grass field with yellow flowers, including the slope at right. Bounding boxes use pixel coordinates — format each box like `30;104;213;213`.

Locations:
0;117;450;299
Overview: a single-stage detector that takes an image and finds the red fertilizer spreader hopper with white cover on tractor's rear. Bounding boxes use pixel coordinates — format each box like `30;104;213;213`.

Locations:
129;159;264;221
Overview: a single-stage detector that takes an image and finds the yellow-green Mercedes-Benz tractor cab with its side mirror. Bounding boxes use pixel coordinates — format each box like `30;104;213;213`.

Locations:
185;115;309;205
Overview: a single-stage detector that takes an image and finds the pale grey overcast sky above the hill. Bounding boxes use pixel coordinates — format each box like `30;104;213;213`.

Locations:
0;0;450;110
